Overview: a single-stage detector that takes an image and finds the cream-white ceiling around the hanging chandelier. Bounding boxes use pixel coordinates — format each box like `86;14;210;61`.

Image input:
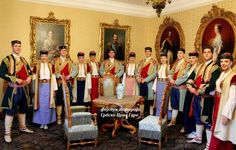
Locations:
21;0;223;18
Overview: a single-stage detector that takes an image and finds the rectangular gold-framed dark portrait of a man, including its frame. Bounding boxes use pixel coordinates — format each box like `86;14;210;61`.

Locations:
100;19;130;62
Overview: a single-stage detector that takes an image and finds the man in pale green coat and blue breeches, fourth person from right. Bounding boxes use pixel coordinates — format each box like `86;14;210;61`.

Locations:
168;48;188;126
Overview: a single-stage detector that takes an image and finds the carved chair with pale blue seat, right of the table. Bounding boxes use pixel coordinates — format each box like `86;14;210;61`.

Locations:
138;83;169;149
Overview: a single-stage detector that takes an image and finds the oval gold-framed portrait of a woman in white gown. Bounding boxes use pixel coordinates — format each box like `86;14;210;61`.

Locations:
195;5;236;60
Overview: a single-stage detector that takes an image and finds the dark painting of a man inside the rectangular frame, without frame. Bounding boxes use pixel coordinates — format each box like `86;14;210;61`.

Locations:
104;29;125;61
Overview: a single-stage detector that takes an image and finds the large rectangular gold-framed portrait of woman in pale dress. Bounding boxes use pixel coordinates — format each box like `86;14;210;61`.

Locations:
30;12;70;66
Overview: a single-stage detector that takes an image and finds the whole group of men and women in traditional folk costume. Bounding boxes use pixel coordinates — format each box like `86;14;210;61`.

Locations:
0;40;236;149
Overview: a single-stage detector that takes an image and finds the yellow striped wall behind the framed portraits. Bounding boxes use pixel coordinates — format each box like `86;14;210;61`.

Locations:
0;0;236;108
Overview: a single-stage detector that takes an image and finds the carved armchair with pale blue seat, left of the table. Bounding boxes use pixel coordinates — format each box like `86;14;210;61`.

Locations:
62;79;98;149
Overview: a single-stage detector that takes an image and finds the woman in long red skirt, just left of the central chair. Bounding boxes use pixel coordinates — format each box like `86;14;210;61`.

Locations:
88;51;100;113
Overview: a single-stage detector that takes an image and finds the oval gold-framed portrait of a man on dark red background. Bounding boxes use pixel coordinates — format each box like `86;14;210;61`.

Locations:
155;17;185;65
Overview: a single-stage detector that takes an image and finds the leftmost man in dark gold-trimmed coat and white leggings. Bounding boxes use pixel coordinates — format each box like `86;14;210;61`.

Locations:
0;40;33;143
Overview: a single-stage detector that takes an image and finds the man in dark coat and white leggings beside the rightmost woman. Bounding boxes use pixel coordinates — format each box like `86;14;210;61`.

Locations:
187;46;220;145
